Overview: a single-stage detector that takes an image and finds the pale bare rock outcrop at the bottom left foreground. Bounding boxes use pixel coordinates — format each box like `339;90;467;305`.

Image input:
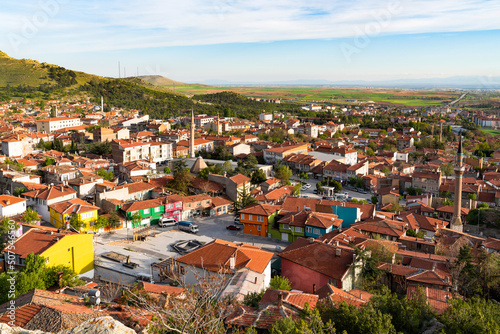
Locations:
0;317;135;334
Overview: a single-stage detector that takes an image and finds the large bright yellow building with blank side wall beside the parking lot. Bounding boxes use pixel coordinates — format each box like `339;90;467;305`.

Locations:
4;228;94;274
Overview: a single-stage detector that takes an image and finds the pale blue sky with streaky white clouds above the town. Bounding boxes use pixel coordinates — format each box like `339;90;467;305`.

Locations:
0;0;500;83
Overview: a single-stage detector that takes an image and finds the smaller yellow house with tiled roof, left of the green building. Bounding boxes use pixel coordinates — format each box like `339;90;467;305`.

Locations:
49;198;99;232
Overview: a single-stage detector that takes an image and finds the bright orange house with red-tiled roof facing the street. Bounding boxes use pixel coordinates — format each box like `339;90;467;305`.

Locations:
240;203;281;237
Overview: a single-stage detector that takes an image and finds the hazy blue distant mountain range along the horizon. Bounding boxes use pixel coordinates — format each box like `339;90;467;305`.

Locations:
201;76;500;89
